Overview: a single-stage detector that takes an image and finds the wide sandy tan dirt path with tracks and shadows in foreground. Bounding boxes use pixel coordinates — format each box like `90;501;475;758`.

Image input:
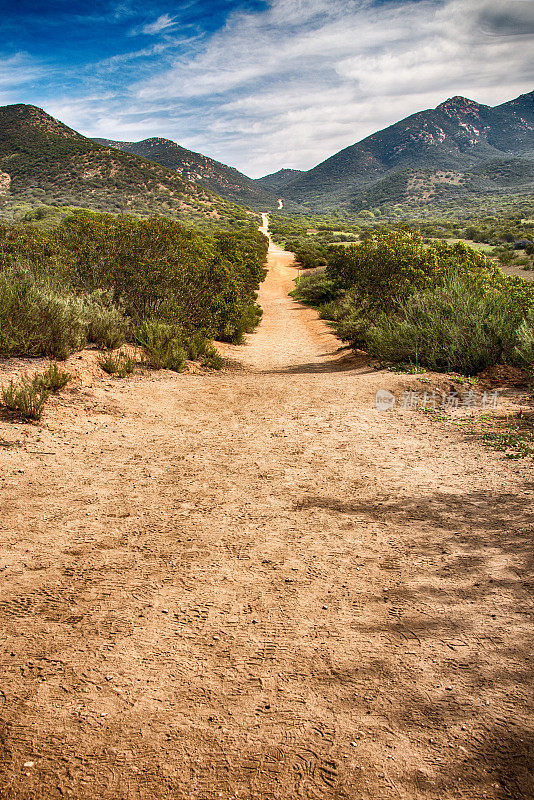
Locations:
0;222;534;800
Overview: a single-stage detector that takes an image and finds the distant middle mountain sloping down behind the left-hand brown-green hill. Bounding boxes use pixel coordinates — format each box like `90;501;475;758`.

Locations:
94;138;277;210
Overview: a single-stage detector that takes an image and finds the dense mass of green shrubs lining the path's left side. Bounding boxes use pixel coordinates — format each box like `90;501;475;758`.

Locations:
0;212;267;364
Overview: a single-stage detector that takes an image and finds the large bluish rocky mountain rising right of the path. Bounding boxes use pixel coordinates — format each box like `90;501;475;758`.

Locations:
283;92;534;208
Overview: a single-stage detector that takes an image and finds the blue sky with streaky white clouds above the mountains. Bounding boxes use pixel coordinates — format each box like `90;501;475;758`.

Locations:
0;0;534;177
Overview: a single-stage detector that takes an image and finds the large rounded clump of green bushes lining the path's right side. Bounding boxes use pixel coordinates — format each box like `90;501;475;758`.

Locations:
293;228;534;375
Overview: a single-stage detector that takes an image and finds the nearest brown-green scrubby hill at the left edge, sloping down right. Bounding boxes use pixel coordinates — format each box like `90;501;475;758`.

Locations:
0;104;253;225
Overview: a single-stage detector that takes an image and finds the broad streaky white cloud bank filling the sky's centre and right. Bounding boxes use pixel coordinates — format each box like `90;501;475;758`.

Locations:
52;0;534;176
